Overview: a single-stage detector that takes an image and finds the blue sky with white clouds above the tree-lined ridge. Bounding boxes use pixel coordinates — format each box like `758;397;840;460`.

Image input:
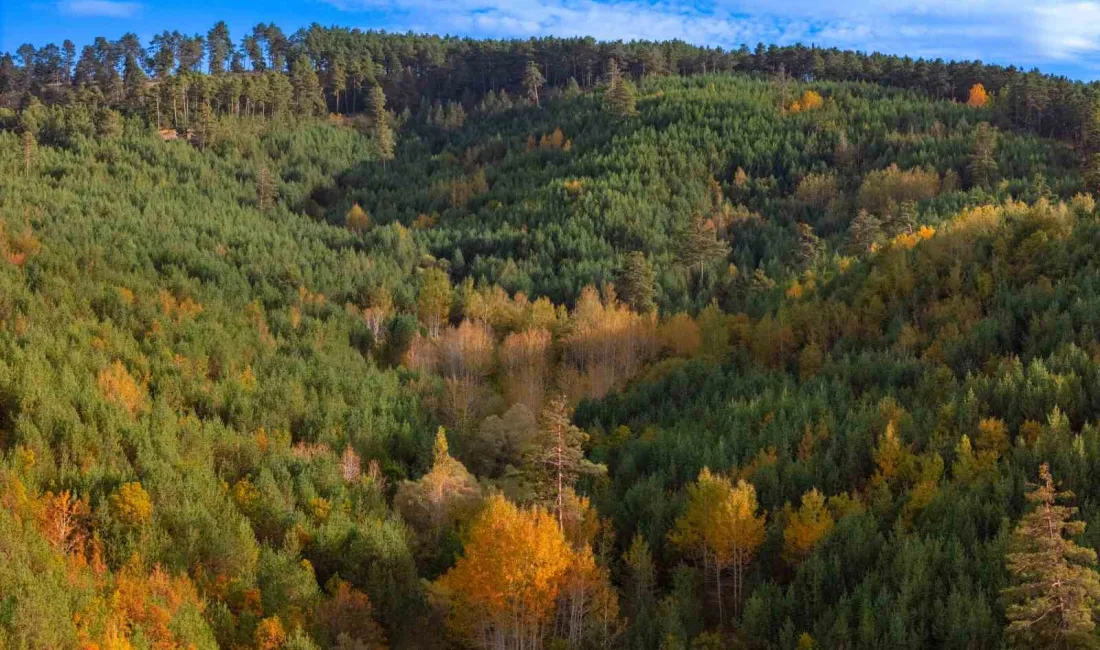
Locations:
0;0;1100;80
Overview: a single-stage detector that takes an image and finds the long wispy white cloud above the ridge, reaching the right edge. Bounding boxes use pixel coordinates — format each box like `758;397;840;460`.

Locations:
326;0;1100;76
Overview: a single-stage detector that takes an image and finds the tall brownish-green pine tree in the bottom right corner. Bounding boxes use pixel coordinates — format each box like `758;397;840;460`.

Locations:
1001;463;1100;648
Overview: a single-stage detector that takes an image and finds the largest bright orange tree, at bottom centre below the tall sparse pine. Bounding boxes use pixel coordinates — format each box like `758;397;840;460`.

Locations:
435;495;573;650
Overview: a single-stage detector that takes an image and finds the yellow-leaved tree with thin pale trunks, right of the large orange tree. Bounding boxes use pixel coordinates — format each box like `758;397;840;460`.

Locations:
669;467;766;624
